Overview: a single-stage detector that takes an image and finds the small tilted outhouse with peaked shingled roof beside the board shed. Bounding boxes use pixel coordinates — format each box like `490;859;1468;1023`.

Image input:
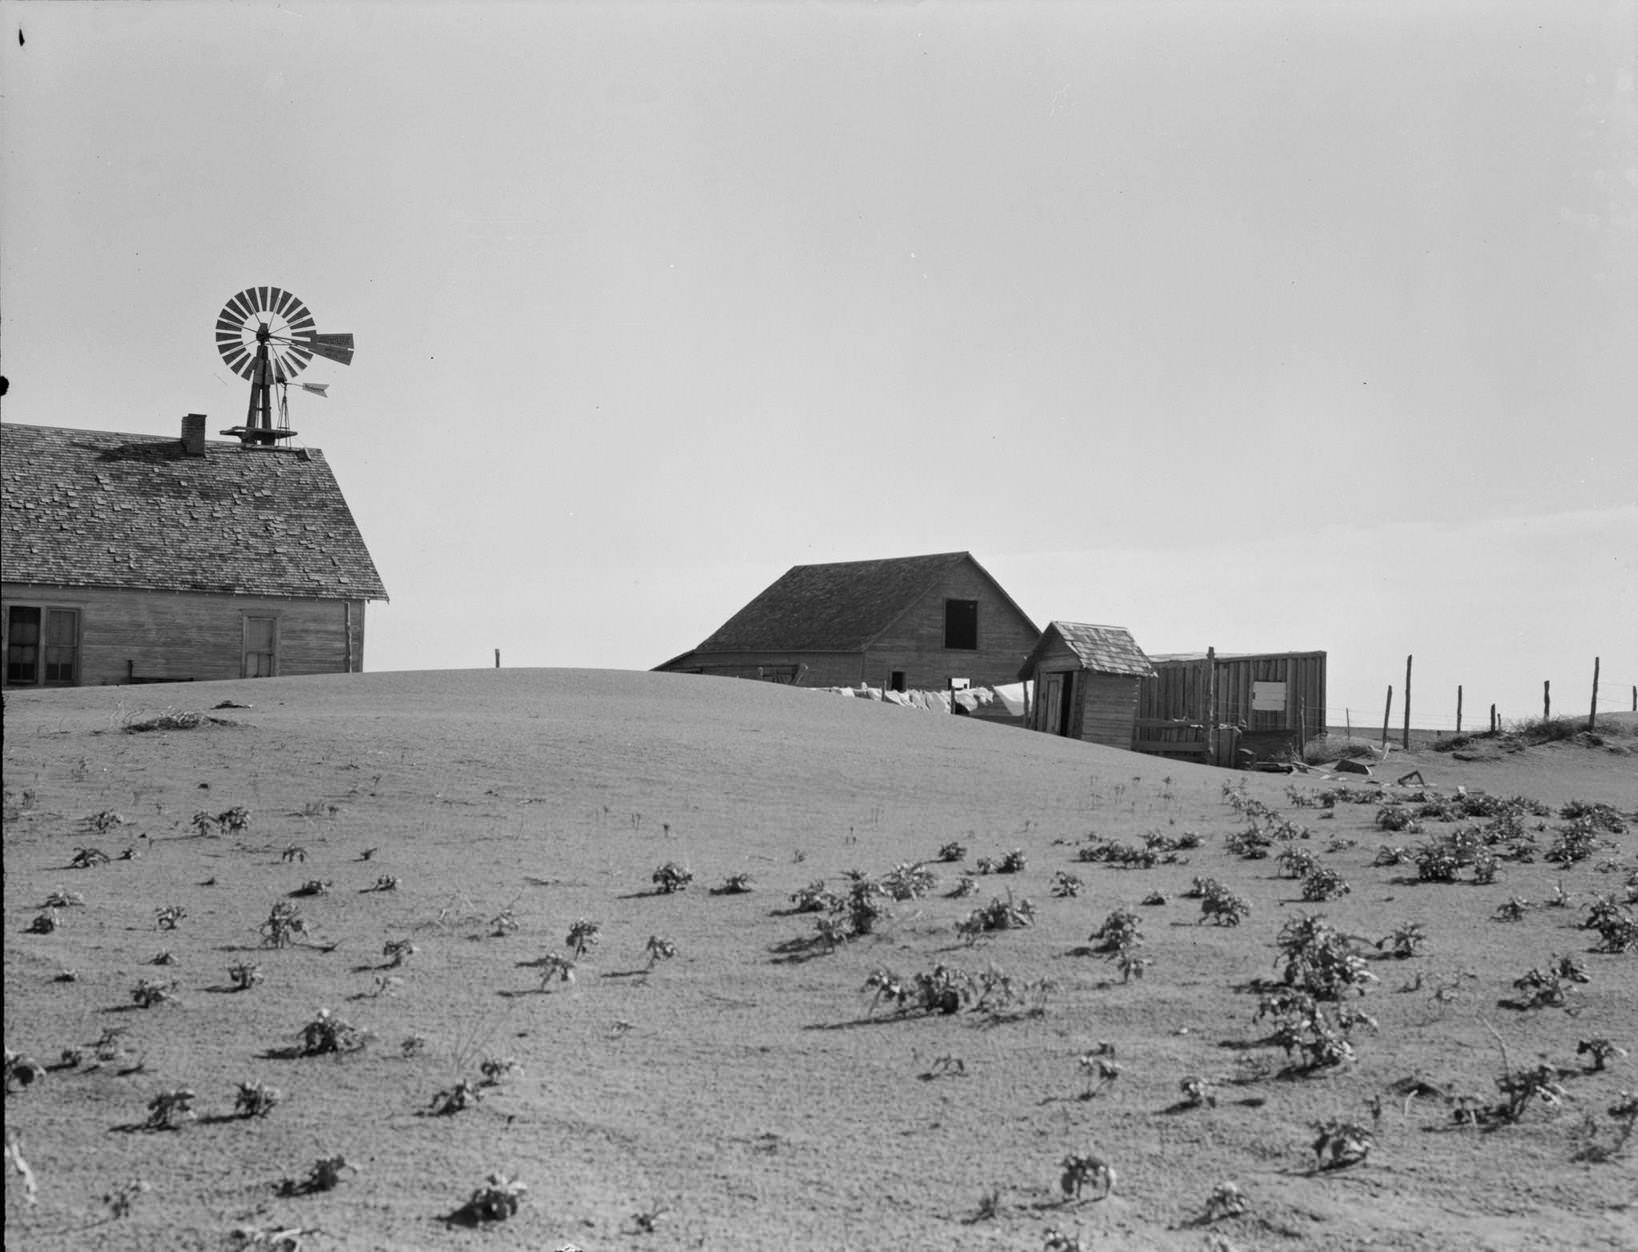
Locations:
1019;621;1155;749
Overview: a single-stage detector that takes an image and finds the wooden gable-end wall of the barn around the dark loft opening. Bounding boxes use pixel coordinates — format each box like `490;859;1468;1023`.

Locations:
863;562;1040;692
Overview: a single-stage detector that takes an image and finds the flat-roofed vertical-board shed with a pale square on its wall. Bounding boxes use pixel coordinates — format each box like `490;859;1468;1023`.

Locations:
1133;649;1325;765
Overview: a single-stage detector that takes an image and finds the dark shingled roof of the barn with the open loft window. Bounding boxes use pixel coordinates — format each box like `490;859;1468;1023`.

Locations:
691;552;1027;664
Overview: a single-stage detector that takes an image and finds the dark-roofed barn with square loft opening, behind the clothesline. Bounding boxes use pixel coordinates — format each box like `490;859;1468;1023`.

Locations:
655;552;1040;692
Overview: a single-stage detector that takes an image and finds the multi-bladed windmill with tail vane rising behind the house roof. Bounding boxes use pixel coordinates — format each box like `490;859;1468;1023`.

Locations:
216;287;352;447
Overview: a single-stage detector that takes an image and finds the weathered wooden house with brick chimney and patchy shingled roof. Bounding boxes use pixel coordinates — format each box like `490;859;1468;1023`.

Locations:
0;413;387;687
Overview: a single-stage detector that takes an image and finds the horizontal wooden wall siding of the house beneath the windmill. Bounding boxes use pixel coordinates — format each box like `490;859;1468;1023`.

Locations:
0;583;365;687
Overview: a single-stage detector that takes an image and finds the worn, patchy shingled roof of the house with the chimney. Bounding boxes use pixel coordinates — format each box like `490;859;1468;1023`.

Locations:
0;423;387;600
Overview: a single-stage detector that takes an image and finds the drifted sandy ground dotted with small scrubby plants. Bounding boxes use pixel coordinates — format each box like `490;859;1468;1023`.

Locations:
3;670;1638;1252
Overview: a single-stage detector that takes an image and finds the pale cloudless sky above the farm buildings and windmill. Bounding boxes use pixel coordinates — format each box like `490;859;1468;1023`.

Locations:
0;0;1638;726
